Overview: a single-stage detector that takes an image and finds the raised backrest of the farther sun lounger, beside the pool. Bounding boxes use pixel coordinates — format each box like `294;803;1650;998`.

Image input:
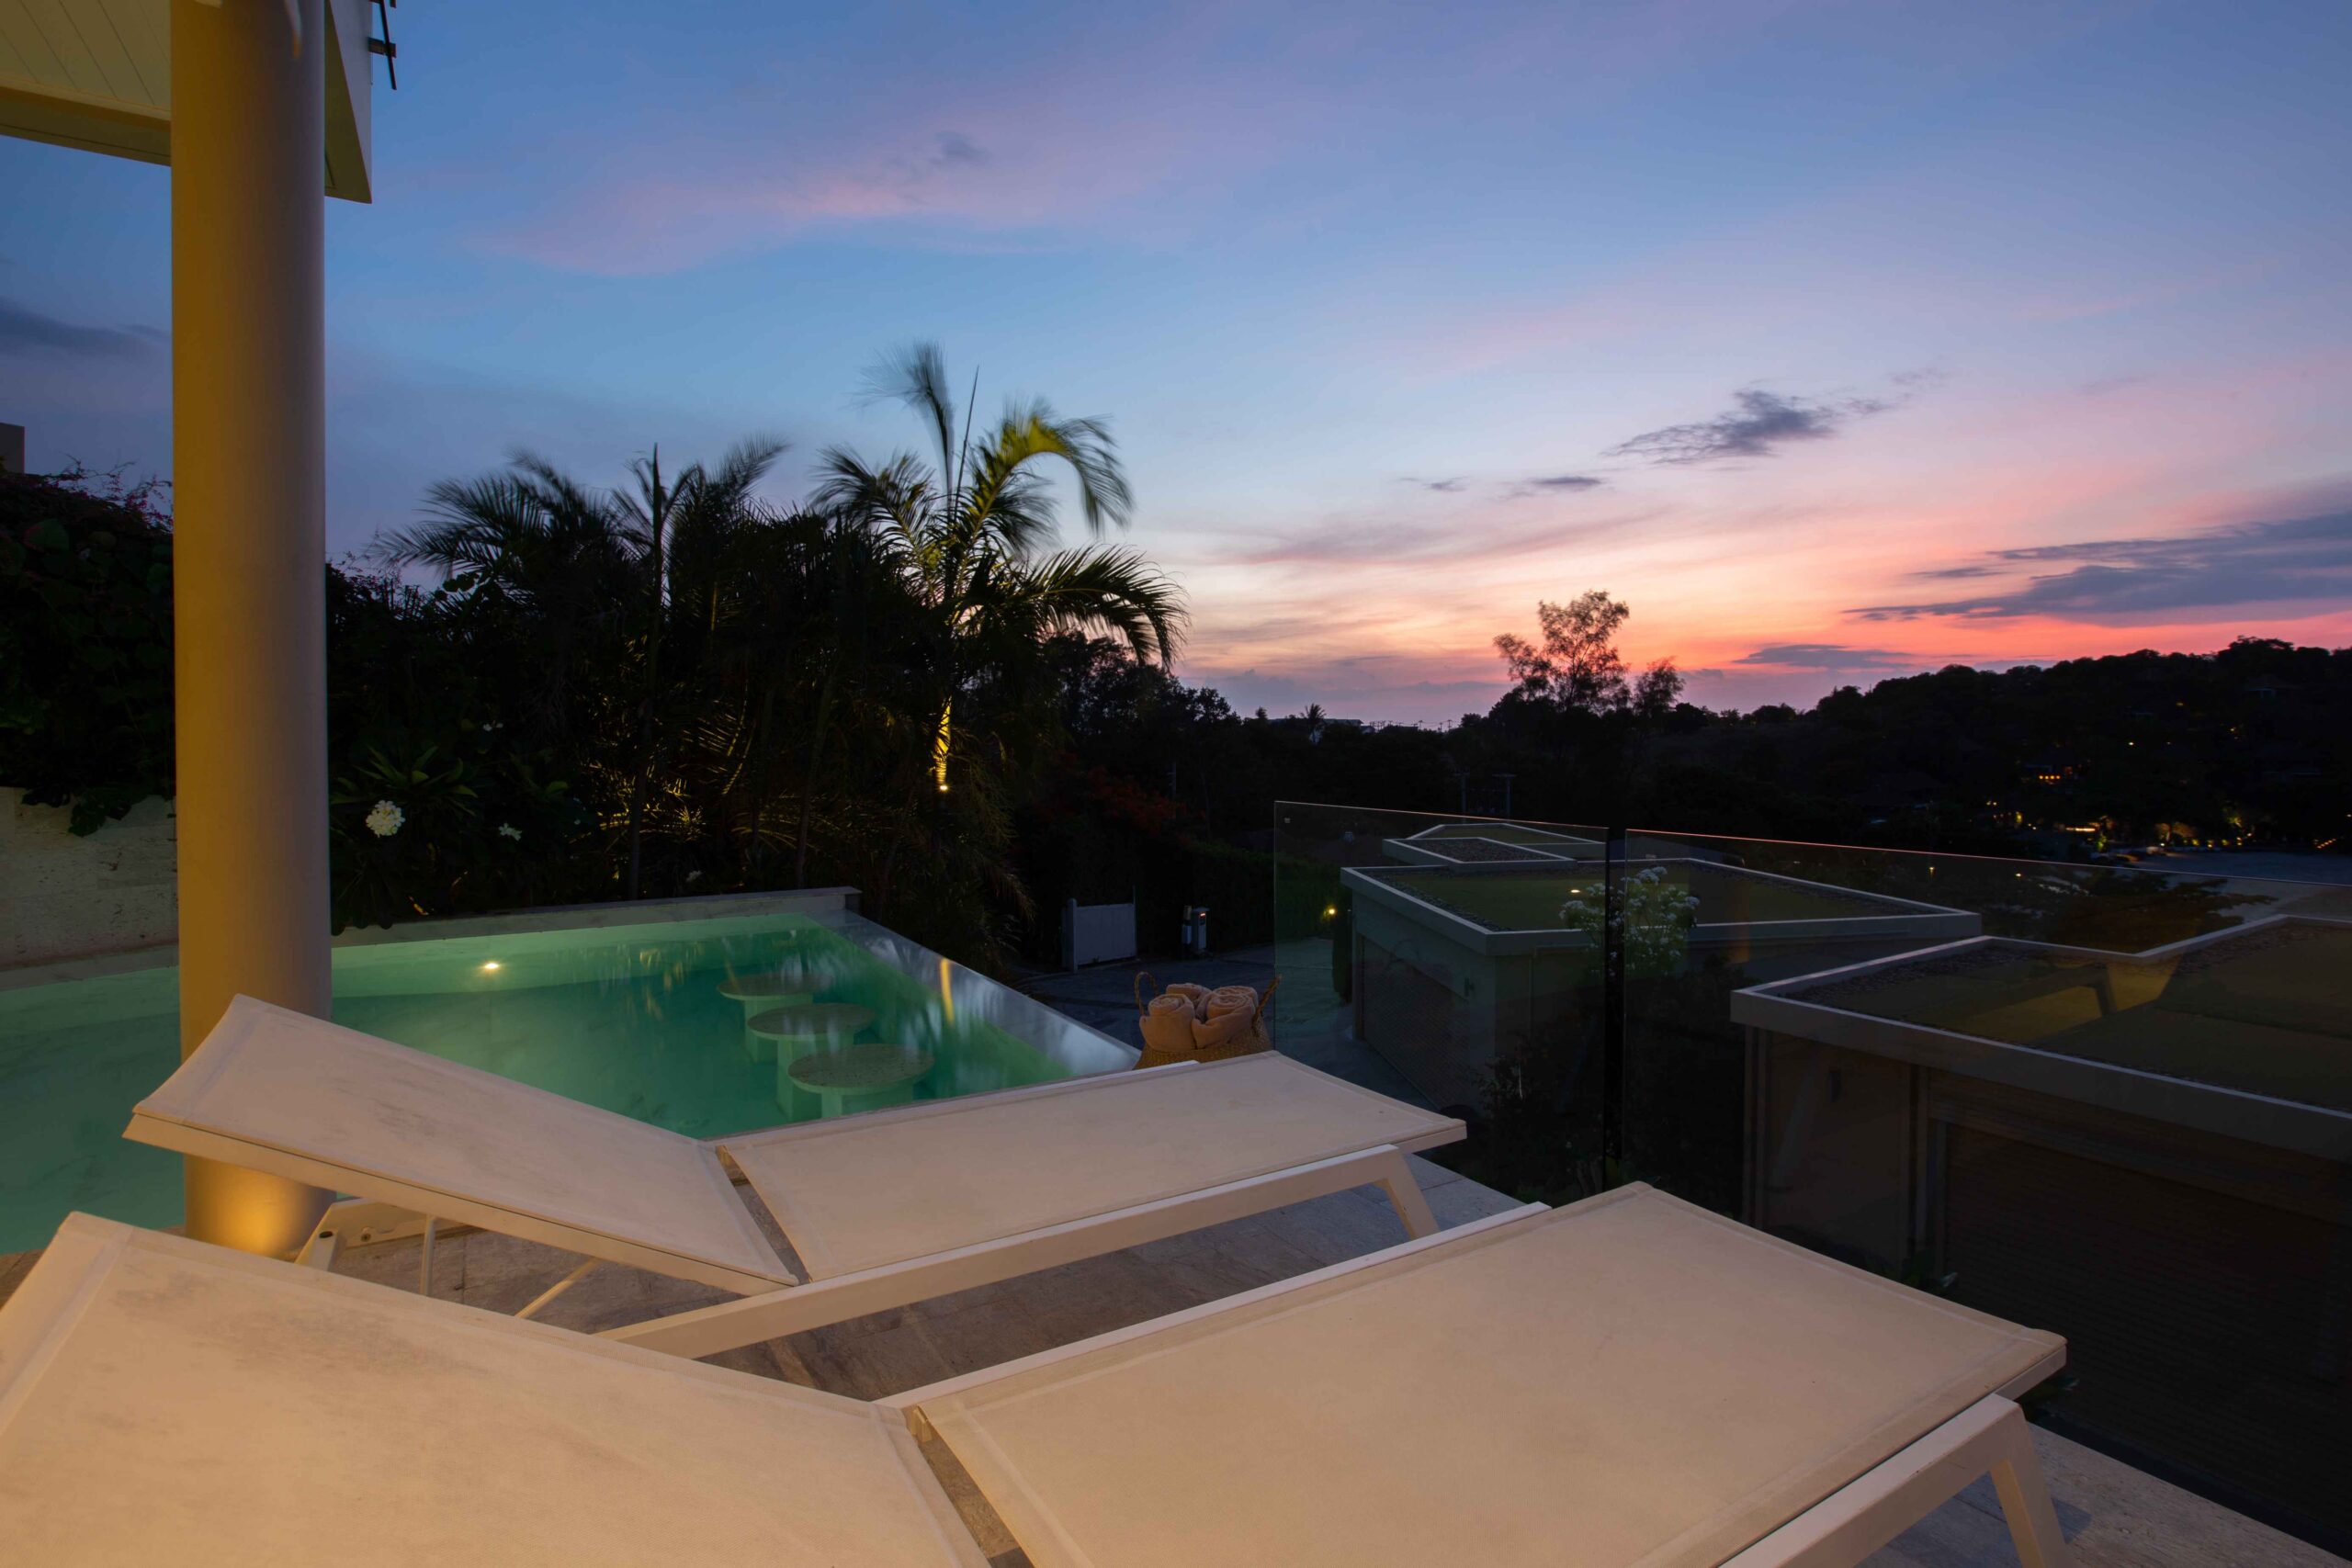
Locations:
127;997;793;1288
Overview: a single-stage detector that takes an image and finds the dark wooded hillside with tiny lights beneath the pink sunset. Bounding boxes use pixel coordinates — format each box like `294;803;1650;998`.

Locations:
1025;639;2352;902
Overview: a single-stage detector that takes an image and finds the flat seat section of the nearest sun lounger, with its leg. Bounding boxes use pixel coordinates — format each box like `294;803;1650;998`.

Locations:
882;1185;2065;1568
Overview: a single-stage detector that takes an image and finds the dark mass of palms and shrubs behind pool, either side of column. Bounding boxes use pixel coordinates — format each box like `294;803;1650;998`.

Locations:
0;348;1183;964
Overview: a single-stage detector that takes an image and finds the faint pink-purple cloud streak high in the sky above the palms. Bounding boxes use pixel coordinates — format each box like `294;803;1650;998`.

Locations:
478;7;1345;275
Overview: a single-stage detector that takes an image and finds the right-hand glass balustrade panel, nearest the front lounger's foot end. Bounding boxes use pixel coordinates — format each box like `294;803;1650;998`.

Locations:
1625;832;2352;1542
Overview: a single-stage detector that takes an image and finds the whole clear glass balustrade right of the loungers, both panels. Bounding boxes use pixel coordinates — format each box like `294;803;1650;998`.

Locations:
1275;804;2352;1550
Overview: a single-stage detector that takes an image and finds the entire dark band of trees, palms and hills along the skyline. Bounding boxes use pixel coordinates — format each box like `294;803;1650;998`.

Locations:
0;434;2352;964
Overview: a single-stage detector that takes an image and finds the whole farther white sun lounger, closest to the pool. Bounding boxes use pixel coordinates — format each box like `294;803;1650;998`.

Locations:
127;997;1463;1357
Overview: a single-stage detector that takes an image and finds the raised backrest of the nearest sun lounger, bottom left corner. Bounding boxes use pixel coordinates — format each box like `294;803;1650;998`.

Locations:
0;1215;983;1568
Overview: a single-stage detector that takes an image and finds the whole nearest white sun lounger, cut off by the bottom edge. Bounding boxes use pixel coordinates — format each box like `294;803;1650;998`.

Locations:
0;1190;2065;1568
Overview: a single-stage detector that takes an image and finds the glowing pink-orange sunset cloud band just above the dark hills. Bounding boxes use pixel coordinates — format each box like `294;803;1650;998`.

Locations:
1152;350;2352;717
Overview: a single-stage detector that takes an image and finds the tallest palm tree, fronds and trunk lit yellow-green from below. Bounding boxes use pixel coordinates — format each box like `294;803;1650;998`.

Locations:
816;344;1185;795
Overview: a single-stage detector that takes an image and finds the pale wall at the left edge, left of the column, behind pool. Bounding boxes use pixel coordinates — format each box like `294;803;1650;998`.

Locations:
0;787;179;964
